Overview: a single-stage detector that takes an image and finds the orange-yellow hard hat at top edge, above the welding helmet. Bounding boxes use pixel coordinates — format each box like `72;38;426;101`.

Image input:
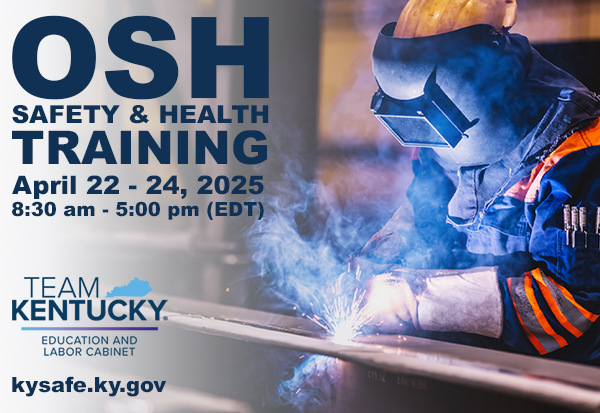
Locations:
394;0;517;38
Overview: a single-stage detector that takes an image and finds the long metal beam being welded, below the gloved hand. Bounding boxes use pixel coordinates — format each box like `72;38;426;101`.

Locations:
150;293;600;413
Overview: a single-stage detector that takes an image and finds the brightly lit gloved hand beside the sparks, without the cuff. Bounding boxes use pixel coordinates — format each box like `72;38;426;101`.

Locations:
364;273;417;331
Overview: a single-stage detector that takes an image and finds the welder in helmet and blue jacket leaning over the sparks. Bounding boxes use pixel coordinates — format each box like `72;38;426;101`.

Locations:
360;0;600;364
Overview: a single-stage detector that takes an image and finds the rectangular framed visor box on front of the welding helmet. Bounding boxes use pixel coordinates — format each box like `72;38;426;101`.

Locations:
371;69;479;148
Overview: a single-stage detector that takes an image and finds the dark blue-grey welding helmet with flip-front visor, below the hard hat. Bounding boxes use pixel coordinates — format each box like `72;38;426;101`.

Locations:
371;23;531;162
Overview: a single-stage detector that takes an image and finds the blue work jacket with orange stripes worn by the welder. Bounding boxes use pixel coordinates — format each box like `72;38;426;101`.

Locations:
406;50;600;365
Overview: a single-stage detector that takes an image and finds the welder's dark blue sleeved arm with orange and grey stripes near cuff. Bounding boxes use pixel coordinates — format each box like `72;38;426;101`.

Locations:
500;147;600;354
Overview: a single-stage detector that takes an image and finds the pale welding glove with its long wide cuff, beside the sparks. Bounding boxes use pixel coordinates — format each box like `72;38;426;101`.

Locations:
367;267;503;338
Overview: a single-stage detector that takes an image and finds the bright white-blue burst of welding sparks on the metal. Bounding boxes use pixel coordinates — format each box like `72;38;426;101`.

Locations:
303;266;372;343
